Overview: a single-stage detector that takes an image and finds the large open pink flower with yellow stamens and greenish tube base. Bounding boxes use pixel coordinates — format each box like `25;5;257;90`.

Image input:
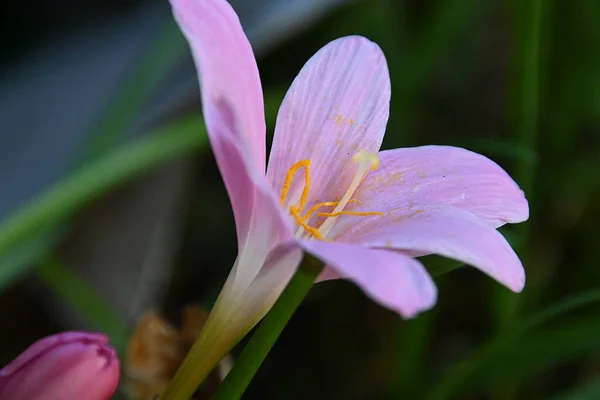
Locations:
171;0;529;368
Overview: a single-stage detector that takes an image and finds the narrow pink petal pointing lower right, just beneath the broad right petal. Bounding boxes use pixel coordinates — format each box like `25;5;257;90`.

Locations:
336;206;525;292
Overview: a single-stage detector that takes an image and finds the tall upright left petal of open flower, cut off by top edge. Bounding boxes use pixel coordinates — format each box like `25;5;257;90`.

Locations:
171;0;271;247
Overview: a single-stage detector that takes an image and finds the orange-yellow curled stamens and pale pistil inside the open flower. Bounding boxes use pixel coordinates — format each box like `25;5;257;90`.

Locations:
280;150;383;240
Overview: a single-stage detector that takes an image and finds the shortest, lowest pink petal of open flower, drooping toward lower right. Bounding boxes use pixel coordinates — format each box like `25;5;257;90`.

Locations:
301;240;437;318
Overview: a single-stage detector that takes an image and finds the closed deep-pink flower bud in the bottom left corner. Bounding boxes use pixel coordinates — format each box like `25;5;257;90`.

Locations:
0;332;119;400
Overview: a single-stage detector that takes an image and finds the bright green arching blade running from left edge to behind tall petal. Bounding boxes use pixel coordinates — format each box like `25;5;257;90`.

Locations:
0;91;283;289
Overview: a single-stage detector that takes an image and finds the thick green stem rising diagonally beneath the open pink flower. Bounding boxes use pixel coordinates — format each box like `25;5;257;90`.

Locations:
212;263;322;400
